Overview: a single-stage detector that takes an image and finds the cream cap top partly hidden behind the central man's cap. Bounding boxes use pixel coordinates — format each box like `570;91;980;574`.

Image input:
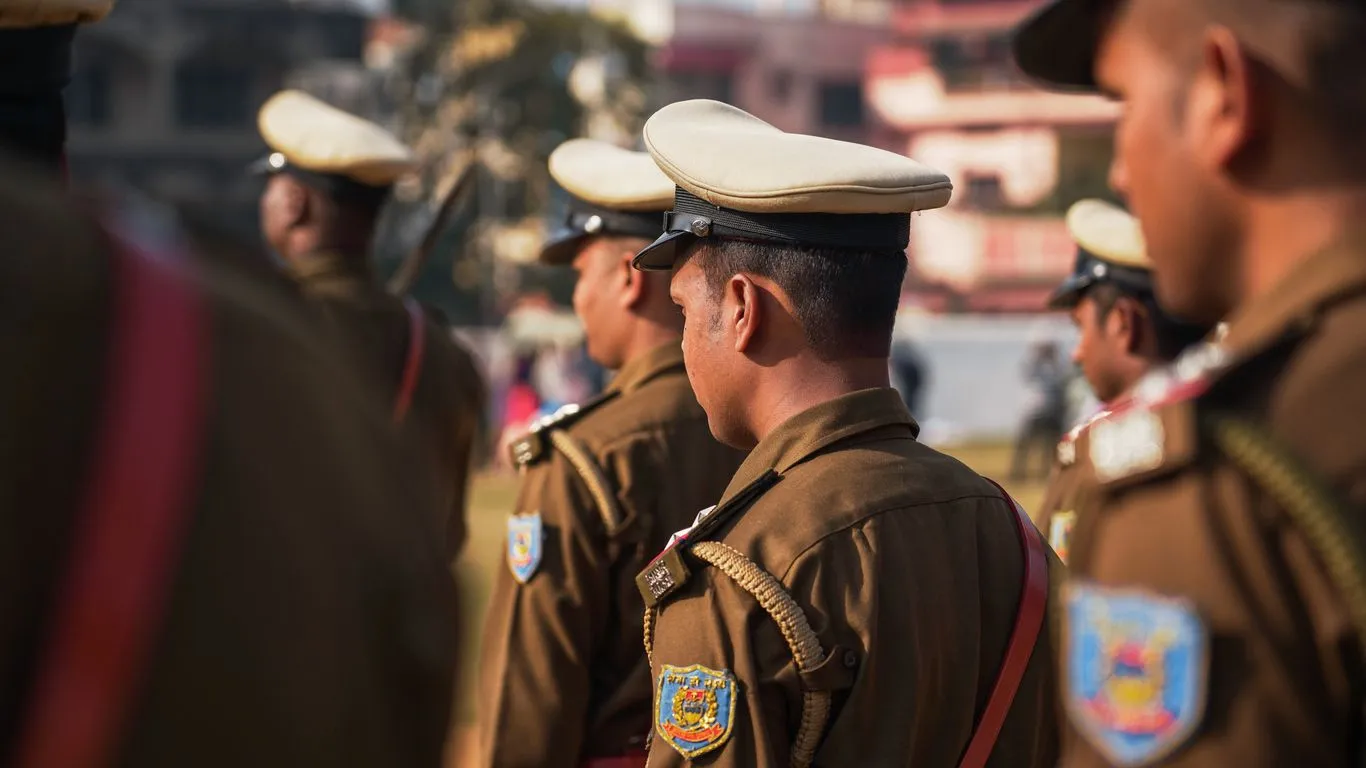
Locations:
549;138;673;212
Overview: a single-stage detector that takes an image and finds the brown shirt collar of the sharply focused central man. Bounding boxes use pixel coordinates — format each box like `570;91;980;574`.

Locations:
721;387;921;504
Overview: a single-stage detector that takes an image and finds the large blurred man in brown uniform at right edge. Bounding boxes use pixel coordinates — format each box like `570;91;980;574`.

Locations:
1016;0;1366;768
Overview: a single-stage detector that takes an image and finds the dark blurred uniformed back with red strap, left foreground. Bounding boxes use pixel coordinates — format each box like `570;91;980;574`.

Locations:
0;151;456;768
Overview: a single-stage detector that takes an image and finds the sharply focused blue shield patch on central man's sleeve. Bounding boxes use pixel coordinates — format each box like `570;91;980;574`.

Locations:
654;664;735;758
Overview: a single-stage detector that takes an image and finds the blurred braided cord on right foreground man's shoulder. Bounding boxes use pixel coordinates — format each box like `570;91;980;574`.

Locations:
1203;414;1366;653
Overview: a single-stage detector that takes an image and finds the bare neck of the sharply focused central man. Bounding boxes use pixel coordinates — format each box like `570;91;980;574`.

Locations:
750;357;891;441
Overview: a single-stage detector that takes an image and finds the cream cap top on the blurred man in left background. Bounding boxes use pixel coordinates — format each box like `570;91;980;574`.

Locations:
257;90;415;186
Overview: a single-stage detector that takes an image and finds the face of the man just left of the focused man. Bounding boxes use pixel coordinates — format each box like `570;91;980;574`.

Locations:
574;236;634;369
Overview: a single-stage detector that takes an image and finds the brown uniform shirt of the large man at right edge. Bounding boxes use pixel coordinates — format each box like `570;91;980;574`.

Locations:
1061;241;1366;768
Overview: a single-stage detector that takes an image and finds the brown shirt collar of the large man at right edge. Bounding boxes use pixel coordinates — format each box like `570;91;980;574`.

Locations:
1221;238;1366;359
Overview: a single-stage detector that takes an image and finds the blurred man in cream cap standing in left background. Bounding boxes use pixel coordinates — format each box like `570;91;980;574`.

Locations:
255;90;485;559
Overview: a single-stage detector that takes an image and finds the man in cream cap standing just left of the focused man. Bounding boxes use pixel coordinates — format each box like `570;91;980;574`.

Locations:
479;139;743;768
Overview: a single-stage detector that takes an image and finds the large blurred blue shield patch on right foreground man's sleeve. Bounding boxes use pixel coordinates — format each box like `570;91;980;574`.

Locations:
1063;582;1209;768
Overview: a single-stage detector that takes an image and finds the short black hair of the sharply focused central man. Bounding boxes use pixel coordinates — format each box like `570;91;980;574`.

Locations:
690;239;907;359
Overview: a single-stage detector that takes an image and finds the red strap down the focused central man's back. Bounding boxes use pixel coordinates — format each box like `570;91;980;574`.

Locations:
959;481;1048;768
